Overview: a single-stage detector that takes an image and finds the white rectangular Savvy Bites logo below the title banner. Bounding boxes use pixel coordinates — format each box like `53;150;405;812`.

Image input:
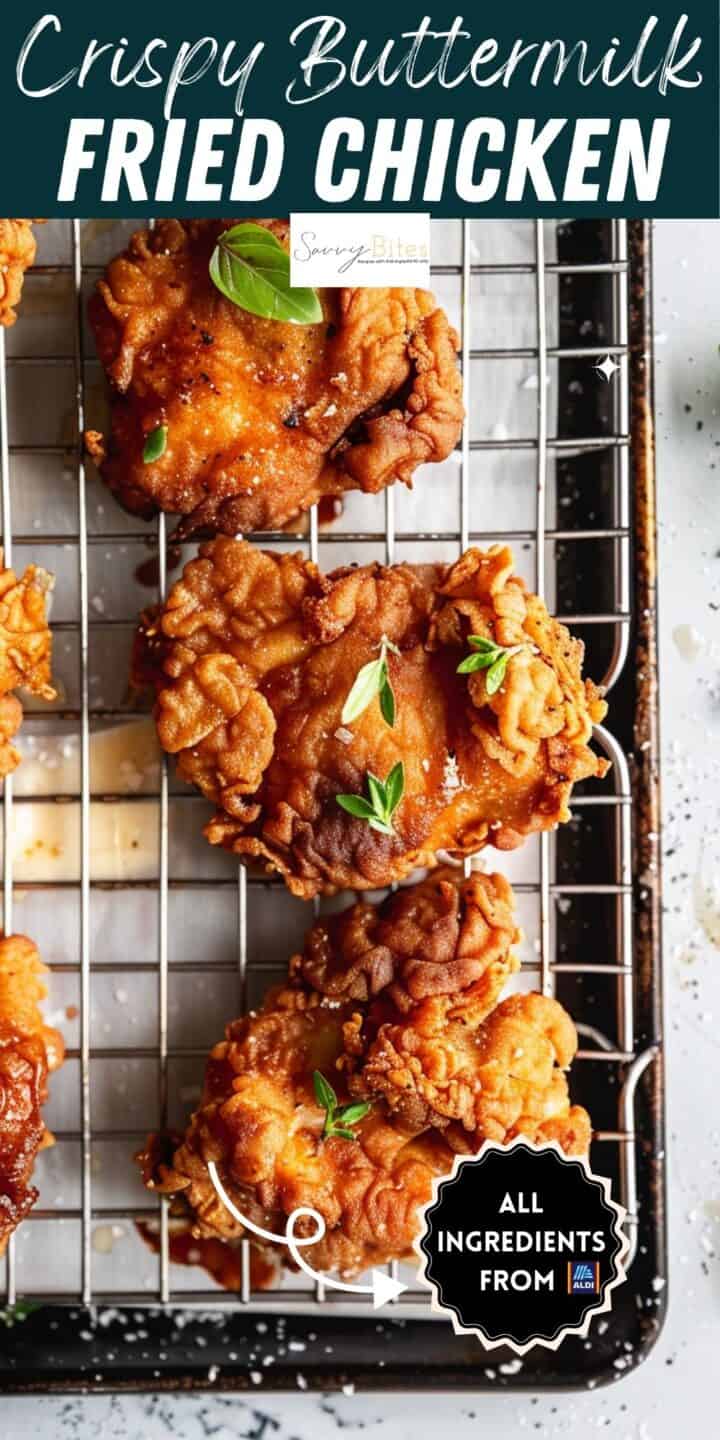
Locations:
289;213;431;289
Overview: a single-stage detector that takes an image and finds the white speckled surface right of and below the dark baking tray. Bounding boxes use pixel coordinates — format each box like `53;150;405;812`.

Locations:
1;220;720;1440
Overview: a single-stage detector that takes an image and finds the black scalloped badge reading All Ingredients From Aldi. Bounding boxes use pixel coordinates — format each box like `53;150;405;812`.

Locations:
418;1139;626;1354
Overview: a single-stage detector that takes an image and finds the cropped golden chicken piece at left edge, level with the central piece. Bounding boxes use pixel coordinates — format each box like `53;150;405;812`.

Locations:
0;550;55;779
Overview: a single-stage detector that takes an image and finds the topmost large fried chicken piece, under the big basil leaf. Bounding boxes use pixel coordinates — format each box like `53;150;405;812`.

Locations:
86;220;464;534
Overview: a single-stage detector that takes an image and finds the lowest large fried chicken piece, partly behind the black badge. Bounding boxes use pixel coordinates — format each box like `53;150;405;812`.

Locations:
138;871;590;1287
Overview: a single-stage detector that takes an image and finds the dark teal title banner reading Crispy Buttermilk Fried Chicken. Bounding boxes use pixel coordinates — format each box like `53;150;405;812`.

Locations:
0;0;720;219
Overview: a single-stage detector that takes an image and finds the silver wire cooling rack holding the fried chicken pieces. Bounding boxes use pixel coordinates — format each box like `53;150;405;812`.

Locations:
0;208;652;1319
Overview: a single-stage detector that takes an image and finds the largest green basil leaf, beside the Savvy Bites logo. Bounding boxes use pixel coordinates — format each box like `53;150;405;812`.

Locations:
210;222;323;325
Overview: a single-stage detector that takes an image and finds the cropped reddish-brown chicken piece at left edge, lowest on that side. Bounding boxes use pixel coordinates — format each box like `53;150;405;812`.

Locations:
0;935;63;1256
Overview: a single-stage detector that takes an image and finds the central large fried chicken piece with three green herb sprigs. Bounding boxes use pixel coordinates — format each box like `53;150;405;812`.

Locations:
137;537;606;899
